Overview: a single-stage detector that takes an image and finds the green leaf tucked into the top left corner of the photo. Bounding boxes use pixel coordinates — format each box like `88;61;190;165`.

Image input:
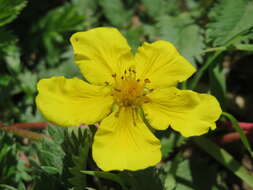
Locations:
0;0;27;26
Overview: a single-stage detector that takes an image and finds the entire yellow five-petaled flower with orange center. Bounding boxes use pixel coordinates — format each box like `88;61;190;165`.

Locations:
36;27;221;171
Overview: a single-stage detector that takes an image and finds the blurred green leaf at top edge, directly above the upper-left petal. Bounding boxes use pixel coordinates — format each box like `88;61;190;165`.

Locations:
99;0;132;28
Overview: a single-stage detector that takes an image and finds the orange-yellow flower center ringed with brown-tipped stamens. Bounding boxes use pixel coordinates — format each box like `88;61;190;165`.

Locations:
109;68;152;107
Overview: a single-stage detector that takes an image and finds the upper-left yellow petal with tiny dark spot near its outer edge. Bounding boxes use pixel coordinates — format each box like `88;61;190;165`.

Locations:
70;27;132;85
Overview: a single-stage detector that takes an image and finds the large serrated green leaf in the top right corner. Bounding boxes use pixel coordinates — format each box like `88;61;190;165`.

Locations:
207;0;253;46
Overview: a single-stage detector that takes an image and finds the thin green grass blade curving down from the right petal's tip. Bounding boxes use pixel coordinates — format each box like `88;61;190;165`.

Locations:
222;112;253;157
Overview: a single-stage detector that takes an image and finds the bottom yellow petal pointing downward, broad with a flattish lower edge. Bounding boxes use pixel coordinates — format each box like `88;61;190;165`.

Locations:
92;107;161;171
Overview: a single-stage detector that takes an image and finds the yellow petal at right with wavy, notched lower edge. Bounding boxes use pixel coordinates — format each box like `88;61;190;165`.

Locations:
143;88;221;137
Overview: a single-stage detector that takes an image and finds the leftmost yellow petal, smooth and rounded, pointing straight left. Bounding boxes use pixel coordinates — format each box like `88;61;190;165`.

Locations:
36;77;113;127
